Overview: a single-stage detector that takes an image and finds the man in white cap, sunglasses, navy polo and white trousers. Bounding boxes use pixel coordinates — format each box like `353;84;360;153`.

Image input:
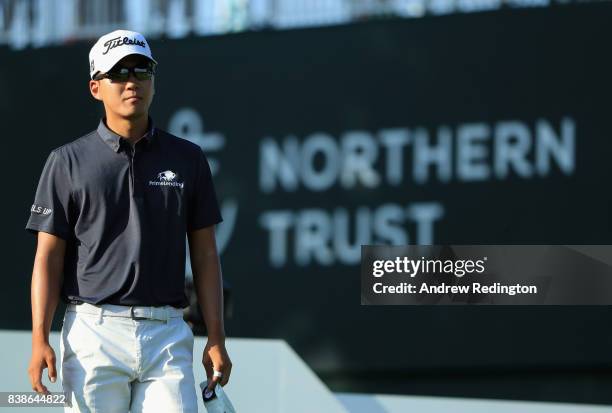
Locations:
26;30;232;413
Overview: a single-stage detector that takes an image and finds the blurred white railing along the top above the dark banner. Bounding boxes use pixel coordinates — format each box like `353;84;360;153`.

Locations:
0;0;597;49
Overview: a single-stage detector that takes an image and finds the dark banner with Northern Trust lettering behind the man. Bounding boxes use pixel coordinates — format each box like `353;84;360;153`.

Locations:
0;4;612;382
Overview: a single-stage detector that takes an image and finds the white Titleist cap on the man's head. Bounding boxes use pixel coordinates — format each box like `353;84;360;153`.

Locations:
89;30;157;79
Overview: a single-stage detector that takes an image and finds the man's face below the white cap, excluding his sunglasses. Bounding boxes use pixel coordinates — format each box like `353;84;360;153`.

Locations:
89;55;155;120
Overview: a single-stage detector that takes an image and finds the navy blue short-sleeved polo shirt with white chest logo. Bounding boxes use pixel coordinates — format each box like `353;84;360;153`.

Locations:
26;118;222;308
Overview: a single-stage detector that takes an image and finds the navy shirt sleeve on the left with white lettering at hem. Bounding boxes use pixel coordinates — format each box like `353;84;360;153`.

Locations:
26;151;72;240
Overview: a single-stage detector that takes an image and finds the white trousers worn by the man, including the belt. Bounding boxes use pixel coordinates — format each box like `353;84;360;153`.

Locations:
60;304;198;413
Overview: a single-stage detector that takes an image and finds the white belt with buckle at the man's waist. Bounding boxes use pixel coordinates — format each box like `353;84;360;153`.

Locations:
66;303;183;321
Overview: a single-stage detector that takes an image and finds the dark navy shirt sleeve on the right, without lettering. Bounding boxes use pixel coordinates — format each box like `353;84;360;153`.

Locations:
187;151;223;231
